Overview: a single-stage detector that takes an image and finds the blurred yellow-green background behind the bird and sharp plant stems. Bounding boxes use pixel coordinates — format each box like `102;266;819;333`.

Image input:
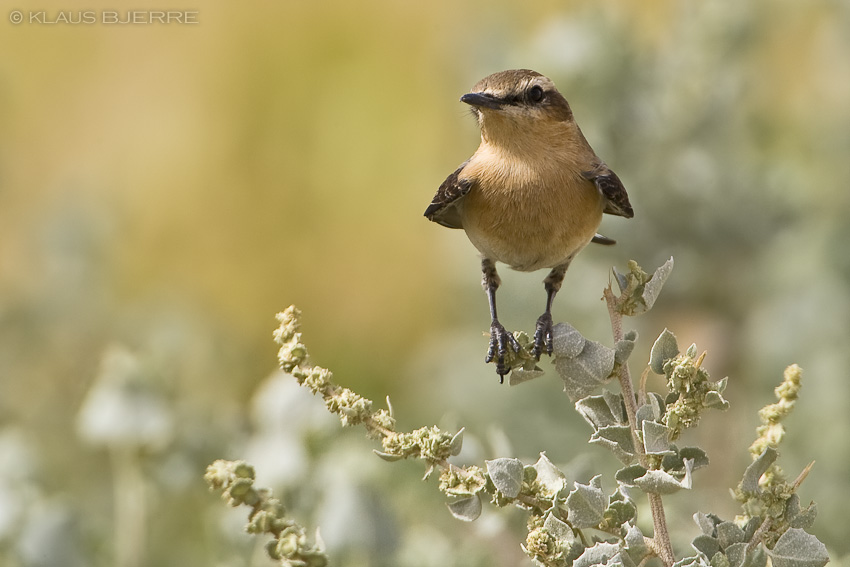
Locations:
0;0;850;567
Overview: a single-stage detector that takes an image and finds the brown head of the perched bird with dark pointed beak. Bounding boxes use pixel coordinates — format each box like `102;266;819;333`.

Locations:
460;69;573;144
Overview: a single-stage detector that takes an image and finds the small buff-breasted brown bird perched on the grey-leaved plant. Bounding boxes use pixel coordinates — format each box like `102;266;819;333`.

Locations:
425;69;634;382
